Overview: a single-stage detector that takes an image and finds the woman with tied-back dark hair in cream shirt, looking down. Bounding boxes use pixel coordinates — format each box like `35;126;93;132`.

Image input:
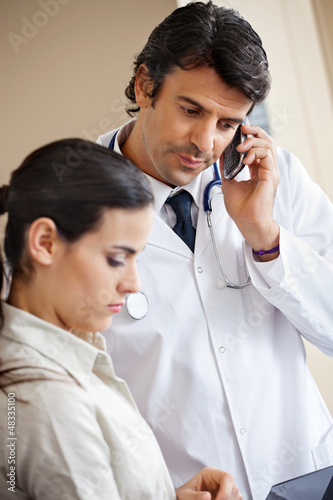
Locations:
0;139;241;500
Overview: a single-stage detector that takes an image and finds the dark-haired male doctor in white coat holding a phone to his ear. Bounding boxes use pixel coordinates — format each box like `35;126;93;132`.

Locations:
98;2;333;500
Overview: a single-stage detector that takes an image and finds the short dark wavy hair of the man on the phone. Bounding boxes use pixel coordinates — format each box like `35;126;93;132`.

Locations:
125;1;271;115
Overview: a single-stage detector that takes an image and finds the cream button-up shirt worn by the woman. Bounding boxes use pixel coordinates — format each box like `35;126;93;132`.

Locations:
0;303;176;500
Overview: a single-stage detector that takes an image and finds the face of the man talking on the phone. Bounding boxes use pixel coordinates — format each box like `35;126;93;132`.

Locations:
135;67;252;186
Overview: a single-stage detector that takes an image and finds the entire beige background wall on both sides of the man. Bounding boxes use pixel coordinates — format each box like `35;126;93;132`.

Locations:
0;0;333;413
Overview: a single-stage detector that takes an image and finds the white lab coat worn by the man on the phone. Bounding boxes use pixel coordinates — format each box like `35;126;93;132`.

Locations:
99;128;333;500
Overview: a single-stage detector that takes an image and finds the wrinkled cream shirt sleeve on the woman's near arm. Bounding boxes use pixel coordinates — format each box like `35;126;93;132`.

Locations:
13;382;121;500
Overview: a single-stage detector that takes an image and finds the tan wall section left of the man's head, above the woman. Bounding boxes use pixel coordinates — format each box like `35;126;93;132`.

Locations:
0;0;176;182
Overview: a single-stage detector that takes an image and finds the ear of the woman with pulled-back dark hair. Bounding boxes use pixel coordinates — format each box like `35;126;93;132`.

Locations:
28;217;59;266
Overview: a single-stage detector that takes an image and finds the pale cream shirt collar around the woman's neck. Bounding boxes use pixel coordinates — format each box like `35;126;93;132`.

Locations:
1;302;114;383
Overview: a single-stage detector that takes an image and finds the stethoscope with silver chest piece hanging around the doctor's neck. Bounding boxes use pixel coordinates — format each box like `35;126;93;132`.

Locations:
108;129;251;319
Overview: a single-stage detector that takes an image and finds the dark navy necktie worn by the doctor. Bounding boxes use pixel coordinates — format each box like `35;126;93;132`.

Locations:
166;191;195;252
